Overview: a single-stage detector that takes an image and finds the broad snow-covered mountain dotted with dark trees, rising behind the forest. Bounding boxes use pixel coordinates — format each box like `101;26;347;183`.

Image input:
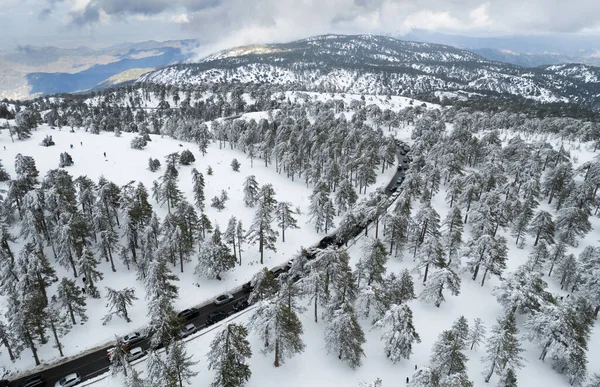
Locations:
139;35;600;110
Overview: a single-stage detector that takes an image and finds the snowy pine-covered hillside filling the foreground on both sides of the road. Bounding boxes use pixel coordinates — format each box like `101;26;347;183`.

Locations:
0;86;600;387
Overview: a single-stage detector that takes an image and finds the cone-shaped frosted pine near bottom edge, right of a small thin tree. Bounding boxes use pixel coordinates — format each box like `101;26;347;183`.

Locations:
482;312;524;383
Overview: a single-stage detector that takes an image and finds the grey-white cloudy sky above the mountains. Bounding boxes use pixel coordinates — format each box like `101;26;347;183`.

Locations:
0;0;600;49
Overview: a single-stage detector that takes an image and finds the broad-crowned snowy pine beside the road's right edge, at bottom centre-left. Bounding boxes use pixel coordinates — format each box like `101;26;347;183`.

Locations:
249;300;305;367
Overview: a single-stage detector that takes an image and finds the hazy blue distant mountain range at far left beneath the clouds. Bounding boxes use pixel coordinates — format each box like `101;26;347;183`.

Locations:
0;40;197;99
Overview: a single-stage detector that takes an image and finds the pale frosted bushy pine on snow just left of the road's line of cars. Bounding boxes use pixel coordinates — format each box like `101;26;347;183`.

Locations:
194;225;236;280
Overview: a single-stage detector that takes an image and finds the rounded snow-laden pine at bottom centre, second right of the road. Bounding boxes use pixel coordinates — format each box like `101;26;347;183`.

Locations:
325;302;366;369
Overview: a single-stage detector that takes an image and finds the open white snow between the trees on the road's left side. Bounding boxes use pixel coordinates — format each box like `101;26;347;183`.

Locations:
0;122;395;372
